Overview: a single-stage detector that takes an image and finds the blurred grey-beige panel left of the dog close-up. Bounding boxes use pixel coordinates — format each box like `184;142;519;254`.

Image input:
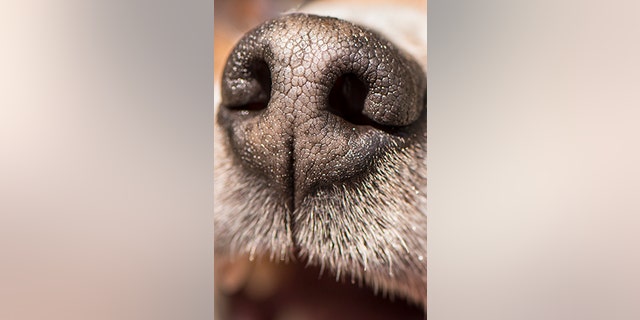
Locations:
0;0;213;320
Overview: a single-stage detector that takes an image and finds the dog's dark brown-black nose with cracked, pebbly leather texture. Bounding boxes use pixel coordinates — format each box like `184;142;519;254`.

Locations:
217;14;427;205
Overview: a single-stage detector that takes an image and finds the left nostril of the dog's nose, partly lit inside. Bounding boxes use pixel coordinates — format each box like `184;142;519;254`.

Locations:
227;60;271;111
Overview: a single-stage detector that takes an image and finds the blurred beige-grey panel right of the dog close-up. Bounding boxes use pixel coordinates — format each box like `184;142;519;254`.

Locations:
428;0;640;320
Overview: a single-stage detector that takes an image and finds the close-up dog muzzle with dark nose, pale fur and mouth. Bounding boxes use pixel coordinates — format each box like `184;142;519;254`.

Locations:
214;4;427;319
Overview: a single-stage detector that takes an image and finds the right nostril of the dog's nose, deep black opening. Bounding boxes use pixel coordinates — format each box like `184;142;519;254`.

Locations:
327;73;374;125
